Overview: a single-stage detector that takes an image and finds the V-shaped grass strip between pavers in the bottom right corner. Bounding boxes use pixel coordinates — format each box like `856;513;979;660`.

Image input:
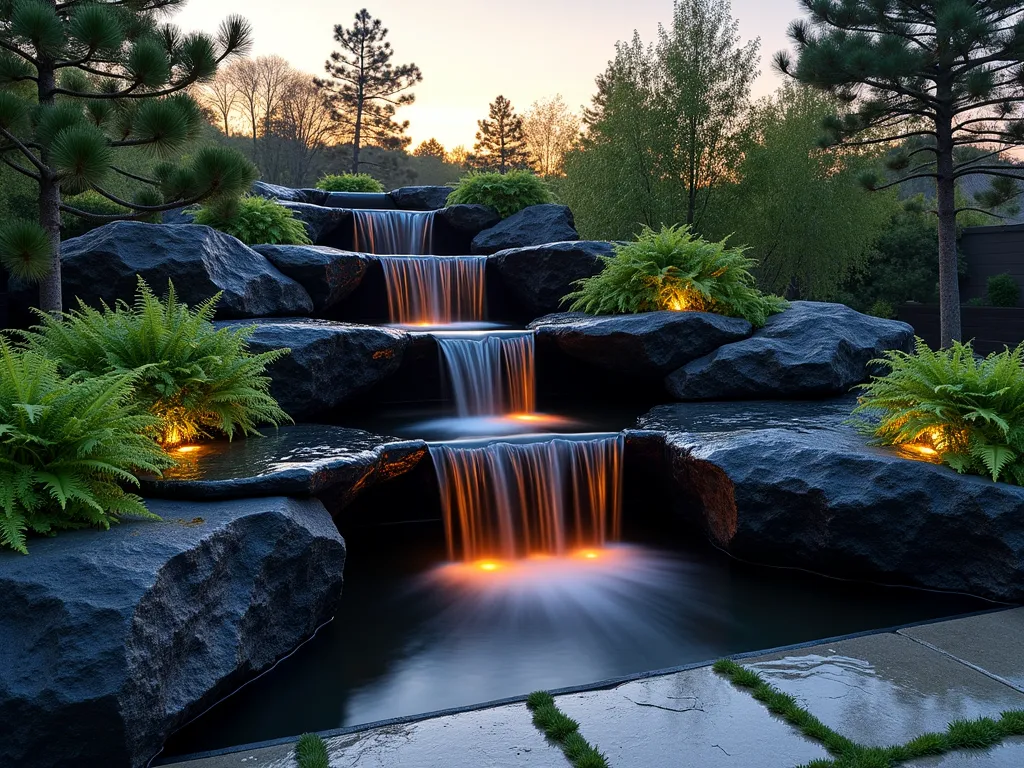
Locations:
714;658;1024;768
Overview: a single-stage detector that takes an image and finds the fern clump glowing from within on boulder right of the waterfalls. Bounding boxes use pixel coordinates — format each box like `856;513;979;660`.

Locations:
564;226;787;328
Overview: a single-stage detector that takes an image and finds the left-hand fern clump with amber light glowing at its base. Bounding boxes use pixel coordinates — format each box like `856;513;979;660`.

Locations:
26;280;289;444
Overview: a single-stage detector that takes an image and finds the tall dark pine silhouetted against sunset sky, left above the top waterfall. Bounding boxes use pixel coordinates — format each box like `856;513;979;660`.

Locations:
316;8;423;173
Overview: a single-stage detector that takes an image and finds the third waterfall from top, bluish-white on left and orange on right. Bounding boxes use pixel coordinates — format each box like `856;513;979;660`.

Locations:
435;332;537;418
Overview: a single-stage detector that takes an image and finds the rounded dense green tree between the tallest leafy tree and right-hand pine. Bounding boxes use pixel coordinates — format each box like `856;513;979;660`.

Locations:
703;84;900;299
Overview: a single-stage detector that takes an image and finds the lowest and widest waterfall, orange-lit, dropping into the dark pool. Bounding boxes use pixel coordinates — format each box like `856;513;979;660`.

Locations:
430;435;624;561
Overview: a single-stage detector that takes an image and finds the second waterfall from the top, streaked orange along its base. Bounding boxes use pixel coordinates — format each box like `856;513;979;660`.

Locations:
380;256;487;326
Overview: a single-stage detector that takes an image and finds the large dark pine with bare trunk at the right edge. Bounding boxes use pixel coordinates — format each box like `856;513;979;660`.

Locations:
775;0;1024;346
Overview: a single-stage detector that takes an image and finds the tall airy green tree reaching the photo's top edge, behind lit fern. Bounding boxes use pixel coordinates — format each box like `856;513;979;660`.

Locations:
563;0;760;238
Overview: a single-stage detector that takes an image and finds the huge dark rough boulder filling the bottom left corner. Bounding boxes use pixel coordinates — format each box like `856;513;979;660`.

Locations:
0;498;345;768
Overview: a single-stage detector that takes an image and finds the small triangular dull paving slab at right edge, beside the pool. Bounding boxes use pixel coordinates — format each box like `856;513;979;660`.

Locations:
899;608;1024;696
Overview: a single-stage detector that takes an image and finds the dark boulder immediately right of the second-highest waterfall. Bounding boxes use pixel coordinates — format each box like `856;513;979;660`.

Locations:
488;241;613;319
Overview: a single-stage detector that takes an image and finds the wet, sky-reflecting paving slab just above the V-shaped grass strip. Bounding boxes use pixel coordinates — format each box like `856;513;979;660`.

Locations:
743;633;1024;746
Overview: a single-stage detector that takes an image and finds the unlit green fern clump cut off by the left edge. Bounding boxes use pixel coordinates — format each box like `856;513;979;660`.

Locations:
0;338;173;553
